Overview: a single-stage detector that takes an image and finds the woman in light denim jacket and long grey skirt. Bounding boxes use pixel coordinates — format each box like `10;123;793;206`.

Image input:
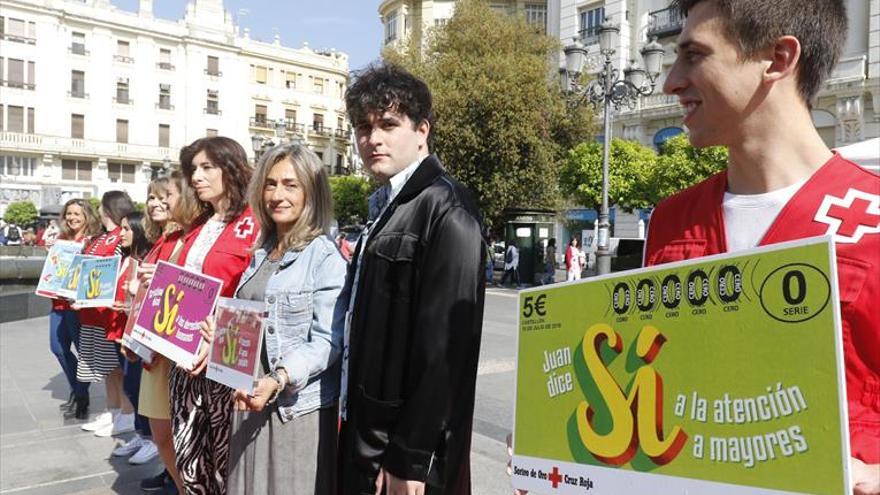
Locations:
222;144;347;495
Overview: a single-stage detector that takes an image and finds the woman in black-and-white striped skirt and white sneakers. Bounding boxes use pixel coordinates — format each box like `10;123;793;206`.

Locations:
76;191;134;437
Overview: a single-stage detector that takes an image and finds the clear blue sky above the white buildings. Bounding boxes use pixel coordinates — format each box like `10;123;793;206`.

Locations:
111;0;382;70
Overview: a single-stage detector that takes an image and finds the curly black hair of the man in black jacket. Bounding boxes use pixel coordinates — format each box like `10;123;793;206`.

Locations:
345;64;434;136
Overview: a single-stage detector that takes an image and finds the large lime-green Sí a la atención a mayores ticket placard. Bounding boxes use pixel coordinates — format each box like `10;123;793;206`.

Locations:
512;239;850;495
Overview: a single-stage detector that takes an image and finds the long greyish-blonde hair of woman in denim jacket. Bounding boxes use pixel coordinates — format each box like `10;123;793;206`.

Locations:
248;144;333;251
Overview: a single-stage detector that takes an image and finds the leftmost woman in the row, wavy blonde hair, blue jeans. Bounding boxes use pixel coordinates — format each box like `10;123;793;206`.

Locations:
49;198;101;419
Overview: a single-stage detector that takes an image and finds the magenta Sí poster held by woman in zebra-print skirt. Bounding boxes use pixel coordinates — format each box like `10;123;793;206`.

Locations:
131;261;223;369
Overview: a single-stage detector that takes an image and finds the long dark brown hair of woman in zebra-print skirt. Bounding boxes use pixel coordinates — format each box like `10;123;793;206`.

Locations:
180;136;253;225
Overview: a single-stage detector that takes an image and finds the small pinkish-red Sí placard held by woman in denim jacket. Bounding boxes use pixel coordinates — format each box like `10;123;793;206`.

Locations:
207;297;266;395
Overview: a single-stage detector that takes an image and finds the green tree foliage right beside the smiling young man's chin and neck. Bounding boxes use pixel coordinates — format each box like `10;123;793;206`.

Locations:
644;134;728;204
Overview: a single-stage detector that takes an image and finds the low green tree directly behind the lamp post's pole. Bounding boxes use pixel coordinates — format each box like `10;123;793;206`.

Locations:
559;138;657;211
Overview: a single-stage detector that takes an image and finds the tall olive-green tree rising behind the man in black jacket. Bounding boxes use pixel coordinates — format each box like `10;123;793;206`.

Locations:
383;0;593;226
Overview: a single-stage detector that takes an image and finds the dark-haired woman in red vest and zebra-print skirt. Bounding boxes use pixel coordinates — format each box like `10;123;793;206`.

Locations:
170;137;259;494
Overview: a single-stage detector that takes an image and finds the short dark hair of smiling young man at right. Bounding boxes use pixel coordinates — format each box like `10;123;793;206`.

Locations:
672;0;847;106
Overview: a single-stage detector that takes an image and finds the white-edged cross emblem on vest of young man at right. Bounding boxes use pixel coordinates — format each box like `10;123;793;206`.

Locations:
813;189;880;244
